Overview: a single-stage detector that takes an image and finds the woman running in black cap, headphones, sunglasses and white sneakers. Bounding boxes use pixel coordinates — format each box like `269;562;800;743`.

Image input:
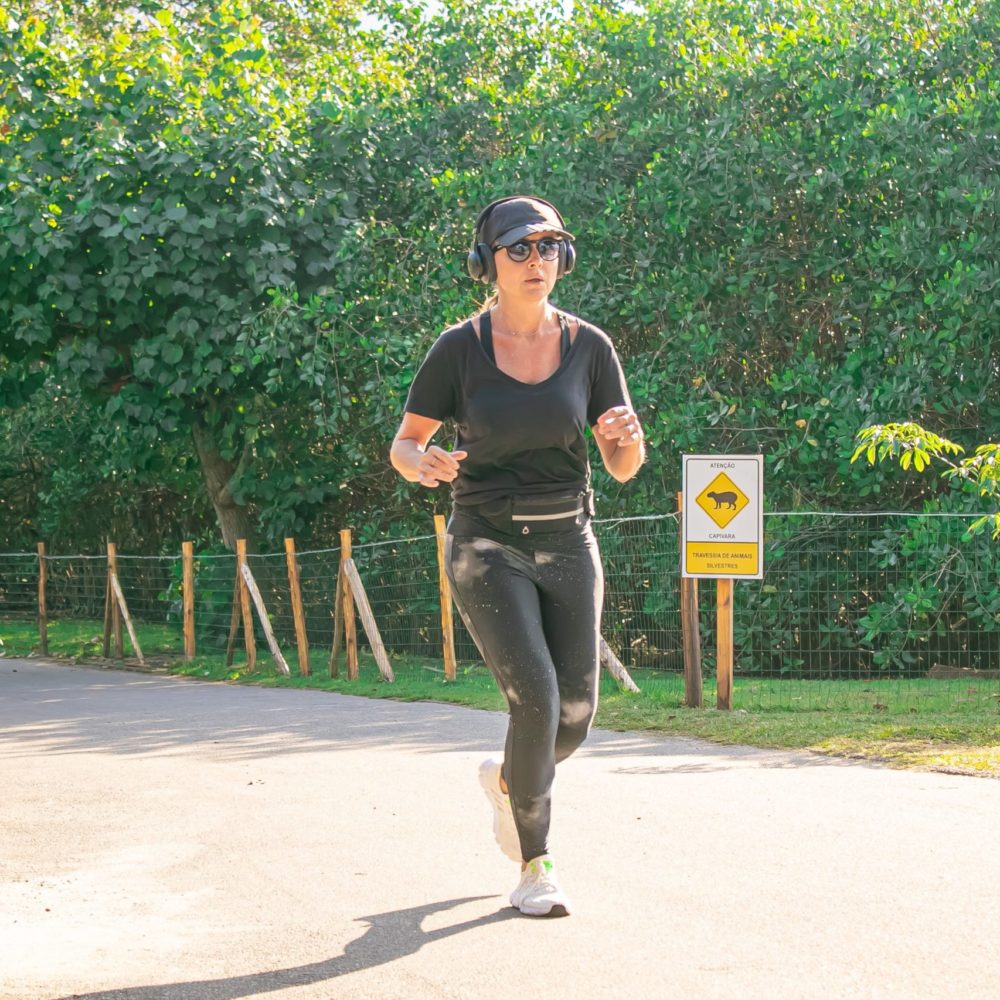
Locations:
390;195;645;916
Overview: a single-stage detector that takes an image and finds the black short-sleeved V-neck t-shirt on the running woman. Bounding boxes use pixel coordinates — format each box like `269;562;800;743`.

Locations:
406;320;631;504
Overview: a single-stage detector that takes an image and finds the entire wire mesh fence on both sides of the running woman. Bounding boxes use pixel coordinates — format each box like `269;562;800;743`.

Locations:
0;513;1000;713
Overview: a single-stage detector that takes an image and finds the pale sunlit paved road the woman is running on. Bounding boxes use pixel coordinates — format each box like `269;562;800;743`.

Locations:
0;660;1000;1000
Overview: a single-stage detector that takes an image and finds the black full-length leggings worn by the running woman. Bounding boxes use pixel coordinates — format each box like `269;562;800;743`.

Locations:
445;525;604;861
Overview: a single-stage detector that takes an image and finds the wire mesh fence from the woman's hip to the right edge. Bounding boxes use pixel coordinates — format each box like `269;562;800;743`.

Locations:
599;513;1000;714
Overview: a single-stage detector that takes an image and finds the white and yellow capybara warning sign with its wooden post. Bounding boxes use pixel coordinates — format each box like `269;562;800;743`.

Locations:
681;455;764;710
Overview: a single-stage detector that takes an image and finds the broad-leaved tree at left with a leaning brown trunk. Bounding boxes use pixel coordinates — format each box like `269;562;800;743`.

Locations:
0;2;366;543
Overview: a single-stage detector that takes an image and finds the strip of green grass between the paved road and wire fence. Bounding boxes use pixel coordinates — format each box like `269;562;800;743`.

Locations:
0;621;1000;777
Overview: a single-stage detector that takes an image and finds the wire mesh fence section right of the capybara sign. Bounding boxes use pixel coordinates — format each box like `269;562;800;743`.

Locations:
728;513;1000;713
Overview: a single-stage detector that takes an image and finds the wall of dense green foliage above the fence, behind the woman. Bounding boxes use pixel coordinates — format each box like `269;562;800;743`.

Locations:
0;0;1000;547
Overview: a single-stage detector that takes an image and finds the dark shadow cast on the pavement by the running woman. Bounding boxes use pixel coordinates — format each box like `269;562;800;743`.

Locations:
61;896;522;1000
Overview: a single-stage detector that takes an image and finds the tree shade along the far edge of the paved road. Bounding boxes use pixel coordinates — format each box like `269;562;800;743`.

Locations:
0;661;847;774
